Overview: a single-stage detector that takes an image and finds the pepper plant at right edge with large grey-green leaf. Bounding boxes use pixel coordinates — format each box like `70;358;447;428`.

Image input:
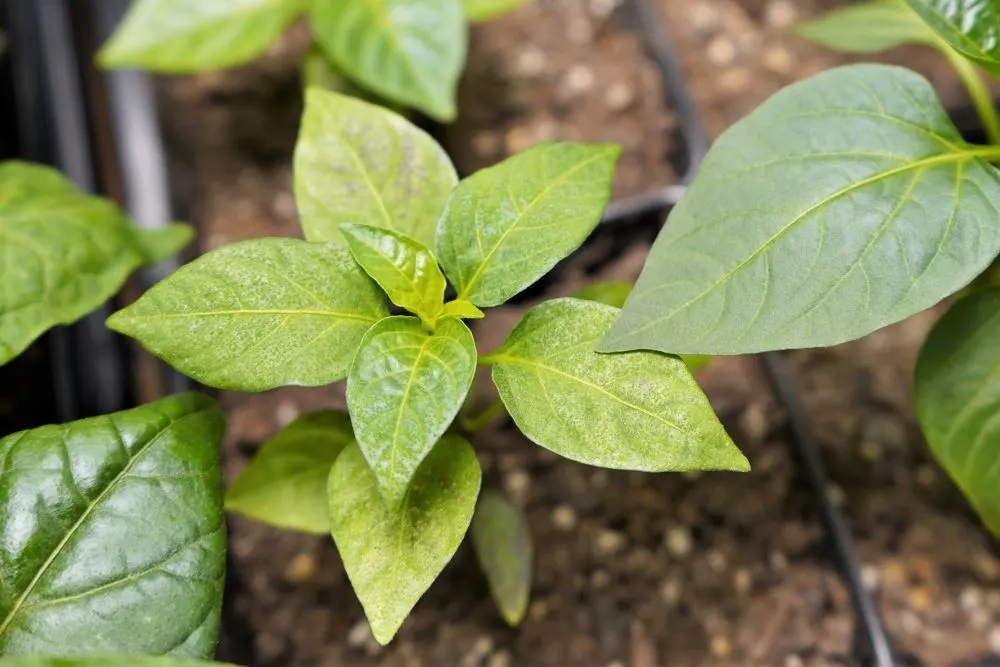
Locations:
598;0;1000;535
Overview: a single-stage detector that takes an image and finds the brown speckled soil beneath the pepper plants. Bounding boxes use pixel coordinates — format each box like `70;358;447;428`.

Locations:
154;0;1000;667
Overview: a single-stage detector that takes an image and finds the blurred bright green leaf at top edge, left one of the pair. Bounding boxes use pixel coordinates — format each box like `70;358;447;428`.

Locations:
97;0;305;74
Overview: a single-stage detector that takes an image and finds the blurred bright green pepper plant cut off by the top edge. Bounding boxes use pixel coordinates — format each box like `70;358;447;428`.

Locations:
98;0;526;121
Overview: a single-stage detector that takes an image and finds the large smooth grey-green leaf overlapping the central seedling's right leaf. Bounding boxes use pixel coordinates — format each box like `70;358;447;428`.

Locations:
598;65;1000;354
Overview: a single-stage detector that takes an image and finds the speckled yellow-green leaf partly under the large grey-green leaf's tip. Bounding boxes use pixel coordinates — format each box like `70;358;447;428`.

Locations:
486;299;750;471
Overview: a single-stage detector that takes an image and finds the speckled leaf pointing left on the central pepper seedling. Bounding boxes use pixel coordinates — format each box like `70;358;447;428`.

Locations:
108;238;388;391
